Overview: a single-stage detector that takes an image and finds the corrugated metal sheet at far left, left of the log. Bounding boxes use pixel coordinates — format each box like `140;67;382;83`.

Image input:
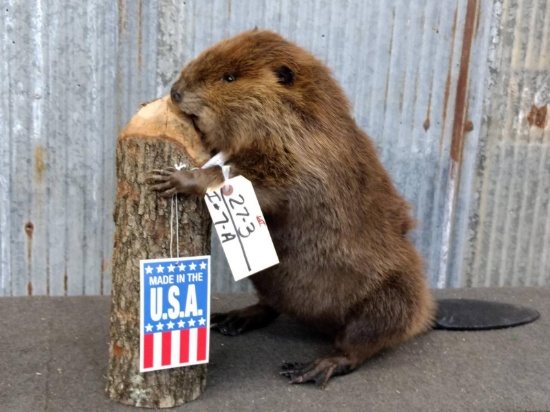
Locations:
0;0;117;295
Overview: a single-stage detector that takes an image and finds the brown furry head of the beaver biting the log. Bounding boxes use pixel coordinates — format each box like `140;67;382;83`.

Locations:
171;30;349;153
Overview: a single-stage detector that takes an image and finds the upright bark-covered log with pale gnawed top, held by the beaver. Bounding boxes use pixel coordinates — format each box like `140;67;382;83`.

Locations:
106;97;211;408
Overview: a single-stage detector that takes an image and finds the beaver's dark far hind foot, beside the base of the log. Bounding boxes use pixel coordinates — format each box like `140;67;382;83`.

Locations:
210;303;279;336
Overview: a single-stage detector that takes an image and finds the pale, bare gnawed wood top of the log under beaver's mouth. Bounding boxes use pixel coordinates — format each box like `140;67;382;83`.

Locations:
119;96;210;167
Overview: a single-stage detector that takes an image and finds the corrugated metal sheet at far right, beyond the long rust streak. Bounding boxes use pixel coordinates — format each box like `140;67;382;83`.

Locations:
462;0;550;286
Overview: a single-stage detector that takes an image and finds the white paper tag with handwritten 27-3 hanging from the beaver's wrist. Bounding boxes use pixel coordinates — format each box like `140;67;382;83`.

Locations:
204;176;279;280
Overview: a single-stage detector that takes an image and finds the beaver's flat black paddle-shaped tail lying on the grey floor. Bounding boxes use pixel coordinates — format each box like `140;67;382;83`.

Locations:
435;299;540;330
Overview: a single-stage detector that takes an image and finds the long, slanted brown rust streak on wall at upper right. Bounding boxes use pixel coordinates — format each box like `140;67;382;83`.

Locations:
451;0;477;165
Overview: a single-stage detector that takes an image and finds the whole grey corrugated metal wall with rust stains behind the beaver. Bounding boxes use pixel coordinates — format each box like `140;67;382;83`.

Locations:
0;0;550;296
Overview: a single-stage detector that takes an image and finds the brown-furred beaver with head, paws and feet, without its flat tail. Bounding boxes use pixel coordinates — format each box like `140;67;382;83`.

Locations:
152;31;434;386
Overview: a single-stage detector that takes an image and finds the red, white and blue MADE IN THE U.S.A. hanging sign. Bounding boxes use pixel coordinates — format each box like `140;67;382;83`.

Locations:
139;256;210;372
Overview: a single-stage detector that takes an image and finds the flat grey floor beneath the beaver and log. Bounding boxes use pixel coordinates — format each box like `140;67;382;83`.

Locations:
0;288;550;412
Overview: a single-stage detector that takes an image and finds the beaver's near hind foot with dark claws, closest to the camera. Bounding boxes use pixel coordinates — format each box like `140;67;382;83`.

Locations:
280;356;352;389
